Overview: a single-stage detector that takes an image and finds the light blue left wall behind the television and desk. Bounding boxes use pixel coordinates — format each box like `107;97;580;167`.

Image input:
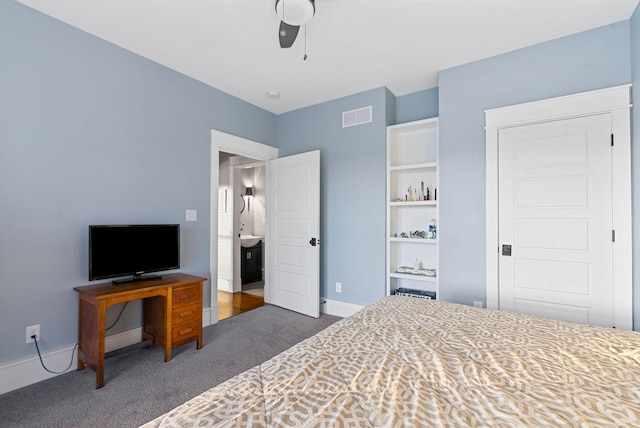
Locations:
0;1;276;363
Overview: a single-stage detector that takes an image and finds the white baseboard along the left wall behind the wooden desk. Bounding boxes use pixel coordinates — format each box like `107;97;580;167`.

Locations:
0;308;217;395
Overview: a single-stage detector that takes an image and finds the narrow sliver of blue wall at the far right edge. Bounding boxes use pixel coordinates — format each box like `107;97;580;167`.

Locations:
630;6;640;331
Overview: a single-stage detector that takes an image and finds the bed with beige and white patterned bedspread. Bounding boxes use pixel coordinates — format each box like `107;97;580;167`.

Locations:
144;296;640;428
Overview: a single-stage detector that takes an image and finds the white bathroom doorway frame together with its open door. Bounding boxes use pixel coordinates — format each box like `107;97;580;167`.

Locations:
209;130;320;323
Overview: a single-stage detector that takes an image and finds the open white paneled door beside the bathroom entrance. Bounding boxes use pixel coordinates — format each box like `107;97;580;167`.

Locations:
269;151;320;318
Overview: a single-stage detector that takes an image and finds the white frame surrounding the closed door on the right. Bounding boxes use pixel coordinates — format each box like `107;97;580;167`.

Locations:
485;84;633;330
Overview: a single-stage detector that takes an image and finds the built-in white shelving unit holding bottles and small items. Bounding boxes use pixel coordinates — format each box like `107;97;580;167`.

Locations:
386;118;440;296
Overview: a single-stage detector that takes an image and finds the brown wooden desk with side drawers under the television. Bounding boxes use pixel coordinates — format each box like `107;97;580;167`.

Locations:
74;273;206;389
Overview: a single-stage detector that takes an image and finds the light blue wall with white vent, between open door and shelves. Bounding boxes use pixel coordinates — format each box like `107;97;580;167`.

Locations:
278;88;393;305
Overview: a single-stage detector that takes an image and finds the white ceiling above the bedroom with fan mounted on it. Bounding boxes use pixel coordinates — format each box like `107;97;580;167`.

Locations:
20;0;639;114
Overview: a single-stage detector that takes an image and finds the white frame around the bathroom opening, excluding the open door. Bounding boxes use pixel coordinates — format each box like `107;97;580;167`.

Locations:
209;129;278;324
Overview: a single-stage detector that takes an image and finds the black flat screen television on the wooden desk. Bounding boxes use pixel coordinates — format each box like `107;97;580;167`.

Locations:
89;224;180;284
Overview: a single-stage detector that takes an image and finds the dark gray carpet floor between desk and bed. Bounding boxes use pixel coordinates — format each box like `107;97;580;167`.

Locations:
0;305;340;428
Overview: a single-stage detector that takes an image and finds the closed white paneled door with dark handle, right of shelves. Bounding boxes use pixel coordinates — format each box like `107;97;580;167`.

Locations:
498;114;614;327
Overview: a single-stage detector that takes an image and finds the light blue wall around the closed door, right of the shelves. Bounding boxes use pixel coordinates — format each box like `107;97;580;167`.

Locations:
438;21;640;314
